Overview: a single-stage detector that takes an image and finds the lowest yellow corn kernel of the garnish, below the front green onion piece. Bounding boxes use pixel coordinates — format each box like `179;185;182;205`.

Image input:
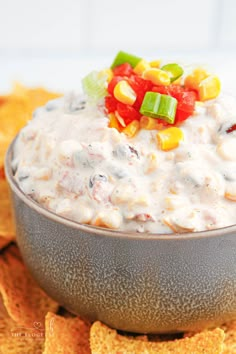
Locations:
157;127;184;151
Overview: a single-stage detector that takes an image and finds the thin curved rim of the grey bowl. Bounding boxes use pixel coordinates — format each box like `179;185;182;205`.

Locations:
4;134;236;241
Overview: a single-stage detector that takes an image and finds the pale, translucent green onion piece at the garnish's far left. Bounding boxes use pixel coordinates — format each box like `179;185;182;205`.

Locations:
82;71;107;101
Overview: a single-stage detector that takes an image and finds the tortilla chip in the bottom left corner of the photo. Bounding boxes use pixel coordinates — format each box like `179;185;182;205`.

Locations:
0;318;44;354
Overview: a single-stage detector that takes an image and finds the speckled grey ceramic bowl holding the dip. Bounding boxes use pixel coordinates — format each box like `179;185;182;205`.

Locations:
6;137;236;333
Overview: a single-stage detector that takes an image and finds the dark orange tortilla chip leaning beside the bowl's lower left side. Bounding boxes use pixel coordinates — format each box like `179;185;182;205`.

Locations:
0;245;58;327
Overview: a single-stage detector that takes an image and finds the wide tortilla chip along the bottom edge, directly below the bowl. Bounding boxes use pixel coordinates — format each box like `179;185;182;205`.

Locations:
90;321;225;354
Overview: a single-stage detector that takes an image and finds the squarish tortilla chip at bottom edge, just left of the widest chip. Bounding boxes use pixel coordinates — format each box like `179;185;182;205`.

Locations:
43;312;91;354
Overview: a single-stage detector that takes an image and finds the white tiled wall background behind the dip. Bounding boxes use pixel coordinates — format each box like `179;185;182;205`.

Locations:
0;0;236;92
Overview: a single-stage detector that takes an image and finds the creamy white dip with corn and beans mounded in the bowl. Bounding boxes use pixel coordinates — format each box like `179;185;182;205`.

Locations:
13;95;236;233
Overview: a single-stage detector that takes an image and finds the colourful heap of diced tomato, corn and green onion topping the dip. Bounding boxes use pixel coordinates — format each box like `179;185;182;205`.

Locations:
83;51;221;150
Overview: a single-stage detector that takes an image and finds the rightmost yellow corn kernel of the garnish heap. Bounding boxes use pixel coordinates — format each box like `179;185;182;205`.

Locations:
198;75;221;101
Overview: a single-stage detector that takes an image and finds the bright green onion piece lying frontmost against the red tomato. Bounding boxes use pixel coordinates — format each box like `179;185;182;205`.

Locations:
140;92;177;124
